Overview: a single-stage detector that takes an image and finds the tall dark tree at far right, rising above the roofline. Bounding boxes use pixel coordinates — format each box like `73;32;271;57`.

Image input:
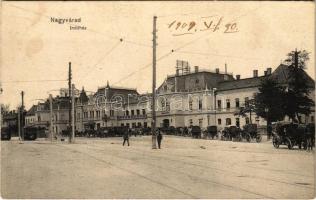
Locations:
285;50;315;123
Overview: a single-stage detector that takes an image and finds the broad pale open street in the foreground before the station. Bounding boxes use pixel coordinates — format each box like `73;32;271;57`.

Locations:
1;136;315;198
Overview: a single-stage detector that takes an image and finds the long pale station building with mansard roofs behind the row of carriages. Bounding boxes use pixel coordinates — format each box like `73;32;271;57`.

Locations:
75;61;315;131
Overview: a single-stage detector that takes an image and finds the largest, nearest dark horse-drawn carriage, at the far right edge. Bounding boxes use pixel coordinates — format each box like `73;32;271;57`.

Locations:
272;122;315;149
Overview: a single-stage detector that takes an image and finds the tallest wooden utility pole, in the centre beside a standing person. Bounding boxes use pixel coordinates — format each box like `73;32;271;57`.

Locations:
151;16;157;149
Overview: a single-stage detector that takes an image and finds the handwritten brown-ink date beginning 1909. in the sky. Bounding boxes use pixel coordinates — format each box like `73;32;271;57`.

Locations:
168;17;239;36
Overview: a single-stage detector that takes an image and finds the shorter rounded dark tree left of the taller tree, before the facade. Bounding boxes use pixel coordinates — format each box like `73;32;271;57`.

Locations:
254;77;286;127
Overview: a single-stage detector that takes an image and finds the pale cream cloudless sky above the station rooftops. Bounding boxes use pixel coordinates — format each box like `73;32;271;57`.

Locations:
0;1;315;109
